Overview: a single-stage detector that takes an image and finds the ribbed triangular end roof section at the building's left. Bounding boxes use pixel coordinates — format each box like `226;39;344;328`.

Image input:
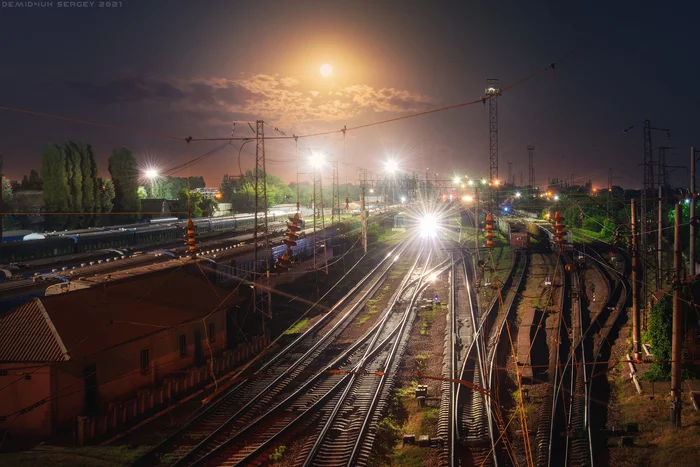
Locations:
0;298;70;363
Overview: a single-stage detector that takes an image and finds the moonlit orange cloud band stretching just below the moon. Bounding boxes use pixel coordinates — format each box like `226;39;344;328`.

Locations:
69;74;434;125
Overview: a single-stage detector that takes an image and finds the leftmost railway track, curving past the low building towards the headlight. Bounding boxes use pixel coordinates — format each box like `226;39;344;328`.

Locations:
132;242;408;466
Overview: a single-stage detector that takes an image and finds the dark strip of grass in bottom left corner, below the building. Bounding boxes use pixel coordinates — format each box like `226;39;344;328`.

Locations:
0;446;150;467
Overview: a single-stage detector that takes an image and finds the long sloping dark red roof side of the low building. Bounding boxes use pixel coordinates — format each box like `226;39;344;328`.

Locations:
0;264;242;361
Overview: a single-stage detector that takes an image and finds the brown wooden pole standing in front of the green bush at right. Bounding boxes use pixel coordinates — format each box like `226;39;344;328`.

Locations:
671;203;684;429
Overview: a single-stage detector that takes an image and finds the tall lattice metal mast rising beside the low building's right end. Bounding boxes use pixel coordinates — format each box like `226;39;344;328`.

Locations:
253;120;272;332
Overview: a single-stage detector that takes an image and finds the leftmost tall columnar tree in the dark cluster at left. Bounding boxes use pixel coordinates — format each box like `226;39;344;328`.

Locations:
41;143;70;229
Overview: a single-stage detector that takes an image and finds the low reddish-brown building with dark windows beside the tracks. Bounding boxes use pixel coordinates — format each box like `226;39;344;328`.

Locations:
0;263;243;438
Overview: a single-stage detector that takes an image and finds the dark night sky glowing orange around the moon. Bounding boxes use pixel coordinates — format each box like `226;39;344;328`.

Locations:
0;0;700;187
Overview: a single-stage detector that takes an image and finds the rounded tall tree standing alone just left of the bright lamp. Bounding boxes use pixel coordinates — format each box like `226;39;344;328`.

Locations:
109;147;141;220
